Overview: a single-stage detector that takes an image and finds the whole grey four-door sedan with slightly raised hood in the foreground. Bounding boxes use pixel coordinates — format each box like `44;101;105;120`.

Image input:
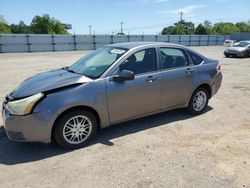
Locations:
2;42;222;148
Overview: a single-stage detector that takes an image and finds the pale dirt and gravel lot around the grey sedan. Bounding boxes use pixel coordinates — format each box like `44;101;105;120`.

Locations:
0;47;250;188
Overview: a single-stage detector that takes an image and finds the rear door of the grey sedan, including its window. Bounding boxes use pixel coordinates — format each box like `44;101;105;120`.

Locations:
159;47;199;109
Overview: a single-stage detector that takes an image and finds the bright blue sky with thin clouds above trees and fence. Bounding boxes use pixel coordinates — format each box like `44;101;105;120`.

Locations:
0;0;250;34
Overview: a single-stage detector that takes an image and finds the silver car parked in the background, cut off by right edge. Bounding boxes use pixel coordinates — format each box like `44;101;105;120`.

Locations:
224;41;250;57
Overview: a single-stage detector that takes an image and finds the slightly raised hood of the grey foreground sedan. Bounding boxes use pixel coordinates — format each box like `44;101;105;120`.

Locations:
11;69;91;98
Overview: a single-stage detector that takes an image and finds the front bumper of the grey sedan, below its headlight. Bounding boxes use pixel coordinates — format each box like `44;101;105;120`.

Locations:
2;107;52;143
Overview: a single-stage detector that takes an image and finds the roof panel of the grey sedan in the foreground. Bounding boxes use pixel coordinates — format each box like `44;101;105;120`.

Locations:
108;42;183;49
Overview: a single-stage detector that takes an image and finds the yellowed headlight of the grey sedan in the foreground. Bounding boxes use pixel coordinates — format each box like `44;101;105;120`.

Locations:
6;93;44;115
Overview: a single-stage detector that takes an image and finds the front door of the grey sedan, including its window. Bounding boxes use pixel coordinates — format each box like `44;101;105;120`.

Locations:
106;48;161;123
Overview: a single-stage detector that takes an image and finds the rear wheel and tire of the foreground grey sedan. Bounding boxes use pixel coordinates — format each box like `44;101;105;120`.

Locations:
187;87;209;115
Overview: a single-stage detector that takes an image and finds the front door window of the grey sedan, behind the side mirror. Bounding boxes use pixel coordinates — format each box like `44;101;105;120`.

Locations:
119;48;157;74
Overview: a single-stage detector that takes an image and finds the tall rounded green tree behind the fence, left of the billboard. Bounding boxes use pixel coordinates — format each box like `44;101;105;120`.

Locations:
31;14;68;34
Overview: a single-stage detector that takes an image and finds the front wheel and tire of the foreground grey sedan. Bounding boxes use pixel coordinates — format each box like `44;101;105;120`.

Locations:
54;110;97;149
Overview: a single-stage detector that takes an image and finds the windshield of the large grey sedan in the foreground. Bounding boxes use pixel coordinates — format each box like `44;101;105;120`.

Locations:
68;47;127;79
